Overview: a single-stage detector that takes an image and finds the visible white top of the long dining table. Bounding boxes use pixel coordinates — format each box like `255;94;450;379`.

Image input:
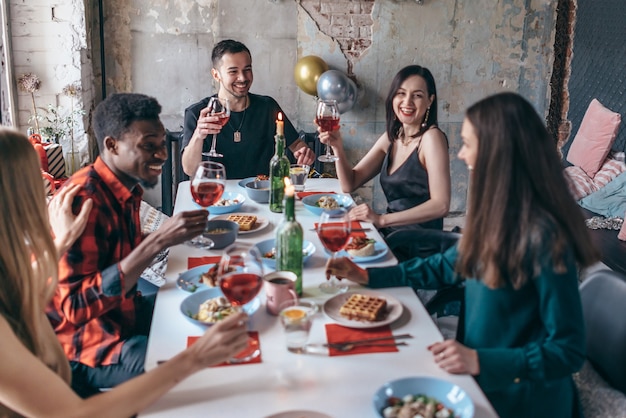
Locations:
140;179;497;418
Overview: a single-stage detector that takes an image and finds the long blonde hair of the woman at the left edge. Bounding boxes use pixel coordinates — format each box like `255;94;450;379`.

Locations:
0;128;58;356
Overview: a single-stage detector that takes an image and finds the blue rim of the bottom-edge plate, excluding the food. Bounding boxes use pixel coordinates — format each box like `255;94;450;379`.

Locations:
373;376;474;418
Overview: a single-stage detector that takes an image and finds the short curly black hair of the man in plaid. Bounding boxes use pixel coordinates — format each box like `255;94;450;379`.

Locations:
93;93;161;153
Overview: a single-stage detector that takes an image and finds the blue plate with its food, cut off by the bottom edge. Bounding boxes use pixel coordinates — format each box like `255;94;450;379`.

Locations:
373;376;474;418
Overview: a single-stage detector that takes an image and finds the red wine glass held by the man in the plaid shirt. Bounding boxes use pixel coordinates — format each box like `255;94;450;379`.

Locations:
185;161;226;250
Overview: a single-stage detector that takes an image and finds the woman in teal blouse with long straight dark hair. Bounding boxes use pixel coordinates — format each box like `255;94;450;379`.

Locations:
327;93;598;418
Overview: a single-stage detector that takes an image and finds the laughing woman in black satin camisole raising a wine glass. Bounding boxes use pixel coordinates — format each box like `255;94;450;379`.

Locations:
318;65;450;234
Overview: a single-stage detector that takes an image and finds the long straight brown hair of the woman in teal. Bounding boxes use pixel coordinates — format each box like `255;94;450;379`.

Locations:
457;93;598;288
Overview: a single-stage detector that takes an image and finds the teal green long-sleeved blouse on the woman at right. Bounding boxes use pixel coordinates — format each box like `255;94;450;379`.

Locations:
368;246;585;418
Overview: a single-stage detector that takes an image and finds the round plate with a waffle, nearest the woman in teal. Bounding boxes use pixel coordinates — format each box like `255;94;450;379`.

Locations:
324;289;403;328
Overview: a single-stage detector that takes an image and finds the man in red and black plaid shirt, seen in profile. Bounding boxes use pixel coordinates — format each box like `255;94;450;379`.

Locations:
47;93;207;396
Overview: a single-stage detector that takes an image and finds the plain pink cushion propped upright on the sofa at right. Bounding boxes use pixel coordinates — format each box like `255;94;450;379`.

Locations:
567;99;622;178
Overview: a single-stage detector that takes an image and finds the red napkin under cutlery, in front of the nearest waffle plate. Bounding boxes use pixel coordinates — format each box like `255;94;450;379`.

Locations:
326;324;399;357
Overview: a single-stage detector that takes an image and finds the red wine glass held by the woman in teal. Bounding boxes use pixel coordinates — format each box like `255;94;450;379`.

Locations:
317;208;351;294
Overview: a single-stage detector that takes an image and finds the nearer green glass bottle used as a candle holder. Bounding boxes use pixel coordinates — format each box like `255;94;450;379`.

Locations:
276;186;302;296
